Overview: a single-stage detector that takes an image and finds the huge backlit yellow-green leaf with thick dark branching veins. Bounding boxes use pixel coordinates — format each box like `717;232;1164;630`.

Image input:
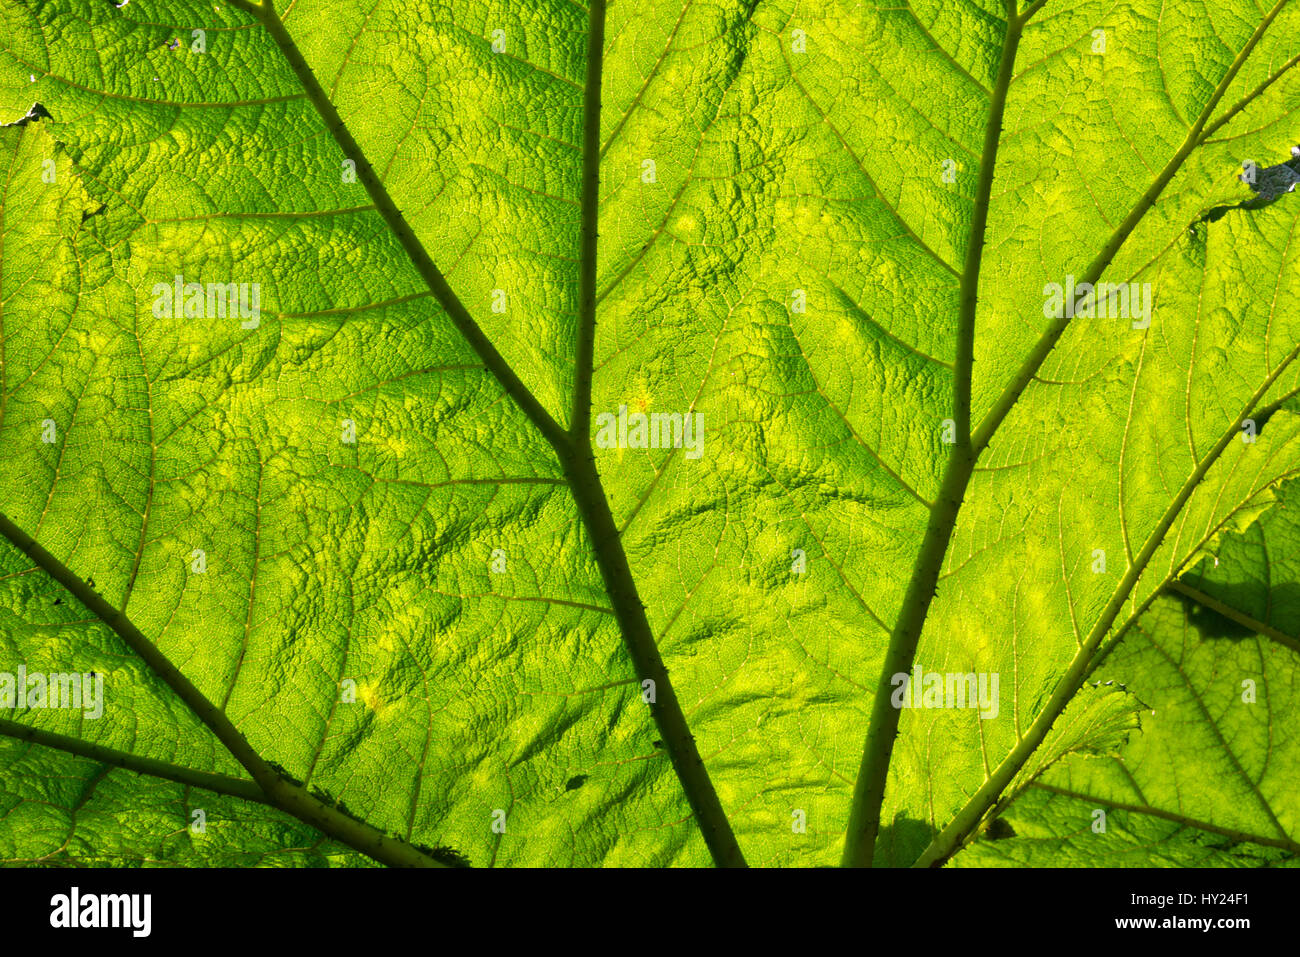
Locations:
0;0;1300;866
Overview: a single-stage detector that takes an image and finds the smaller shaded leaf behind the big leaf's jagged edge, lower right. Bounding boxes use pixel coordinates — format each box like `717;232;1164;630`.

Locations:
954;482;1300;866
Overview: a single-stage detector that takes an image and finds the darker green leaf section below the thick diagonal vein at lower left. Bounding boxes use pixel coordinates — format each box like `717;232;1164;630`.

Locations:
0;530;369;867
